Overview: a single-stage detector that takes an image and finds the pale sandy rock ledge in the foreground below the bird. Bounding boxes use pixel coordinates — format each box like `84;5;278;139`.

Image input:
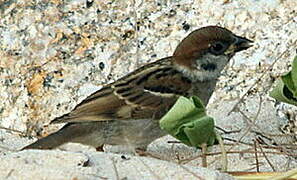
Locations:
0;150;234;180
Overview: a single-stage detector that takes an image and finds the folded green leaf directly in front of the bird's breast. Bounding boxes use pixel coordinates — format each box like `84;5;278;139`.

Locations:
160;96;216;147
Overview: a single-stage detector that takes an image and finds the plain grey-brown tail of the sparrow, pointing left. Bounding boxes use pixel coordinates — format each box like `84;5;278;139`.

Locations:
21;124;74;150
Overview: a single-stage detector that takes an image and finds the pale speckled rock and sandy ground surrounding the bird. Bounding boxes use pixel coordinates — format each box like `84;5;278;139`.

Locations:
0;0;297;179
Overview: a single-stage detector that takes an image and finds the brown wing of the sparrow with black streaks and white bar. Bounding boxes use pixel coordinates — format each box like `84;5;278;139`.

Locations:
52;58;191;123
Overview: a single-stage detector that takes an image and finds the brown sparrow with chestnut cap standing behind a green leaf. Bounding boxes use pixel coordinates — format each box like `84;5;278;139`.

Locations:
23;26;252;151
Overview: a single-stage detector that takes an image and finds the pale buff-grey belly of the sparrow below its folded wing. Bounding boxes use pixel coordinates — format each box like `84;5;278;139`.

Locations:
73;119;167;148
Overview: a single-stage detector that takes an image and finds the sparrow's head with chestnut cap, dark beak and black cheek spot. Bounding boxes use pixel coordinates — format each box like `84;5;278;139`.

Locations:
173;26;252;81
